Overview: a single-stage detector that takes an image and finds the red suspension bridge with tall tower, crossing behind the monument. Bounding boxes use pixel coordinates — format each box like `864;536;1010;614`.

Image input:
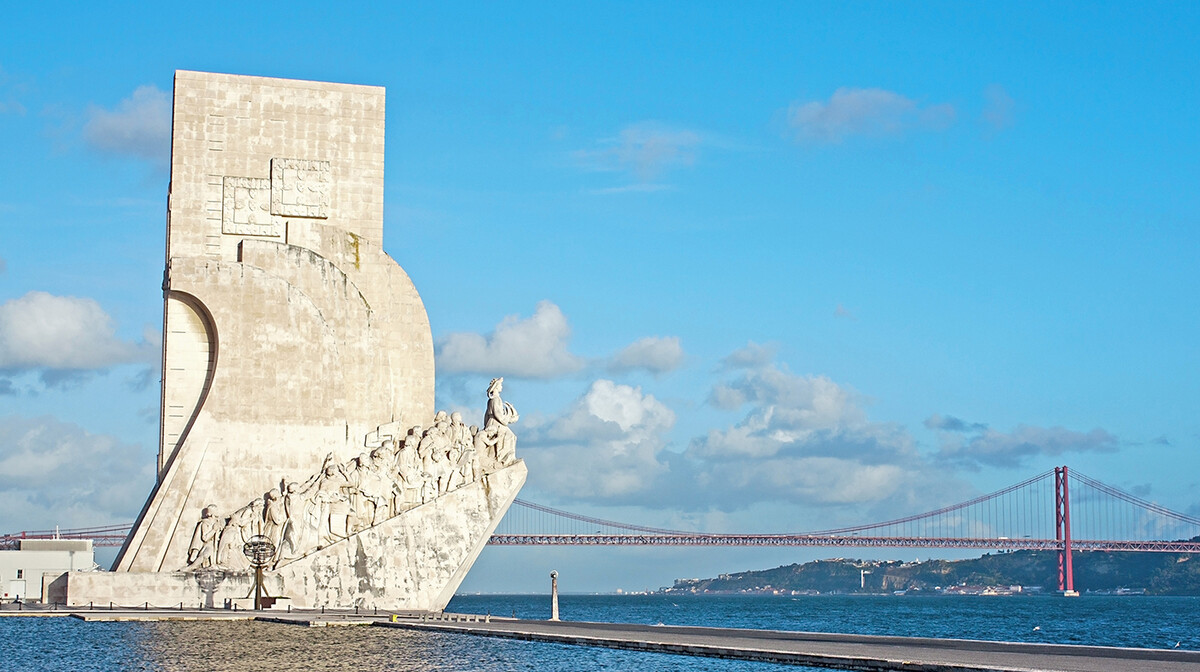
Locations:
0;467;1200;590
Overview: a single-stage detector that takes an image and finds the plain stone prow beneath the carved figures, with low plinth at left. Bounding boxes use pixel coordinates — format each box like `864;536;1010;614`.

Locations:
66;461;527;611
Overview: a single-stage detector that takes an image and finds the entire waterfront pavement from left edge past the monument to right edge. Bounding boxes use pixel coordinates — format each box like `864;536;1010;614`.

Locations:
0;608;1200;672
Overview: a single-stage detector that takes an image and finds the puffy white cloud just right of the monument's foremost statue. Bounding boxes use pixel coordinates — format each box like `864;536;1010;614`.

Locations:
520;379;676;499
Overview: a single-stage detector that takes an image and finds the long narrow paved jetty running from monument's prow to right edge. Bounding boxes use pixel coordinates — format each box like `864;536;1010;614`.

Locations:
376;619;1200;672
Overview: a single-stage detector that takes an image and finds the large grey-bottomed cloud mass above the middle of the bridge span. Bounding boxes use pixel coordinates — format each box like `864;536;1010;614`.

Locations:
684;362;960;508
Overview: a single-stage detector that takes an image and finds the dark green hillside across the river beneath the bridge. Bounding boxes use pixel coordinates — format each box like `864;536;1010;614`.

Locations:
664;549;1200;595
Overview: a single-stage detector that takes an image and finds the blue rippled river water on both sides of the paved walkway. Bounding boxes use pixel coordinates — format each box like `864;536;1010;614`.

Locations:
0;595;1200;672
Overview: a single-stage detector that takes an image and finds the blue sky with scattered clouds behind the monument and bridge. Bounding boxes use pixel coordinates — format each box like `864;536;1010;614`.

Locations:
0;2;1200;590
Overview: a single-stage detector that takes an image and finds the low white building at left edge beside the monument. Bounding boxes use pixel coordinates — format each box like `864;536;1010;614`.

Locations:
0;539;96;601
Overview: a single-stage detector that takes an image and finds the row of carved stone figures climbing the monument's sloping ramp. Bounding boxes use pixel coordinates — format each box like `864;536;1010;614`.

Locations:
180;378;518;572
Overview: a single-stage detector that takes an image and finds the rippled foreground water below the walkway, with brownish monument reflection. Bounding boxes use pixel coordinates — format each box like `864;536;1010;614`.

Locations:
0;618;805;672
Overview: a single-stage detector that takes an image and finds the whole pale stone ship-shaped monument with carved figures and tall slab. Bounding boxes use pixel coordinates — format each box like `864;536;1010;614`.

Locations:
68;71;526;610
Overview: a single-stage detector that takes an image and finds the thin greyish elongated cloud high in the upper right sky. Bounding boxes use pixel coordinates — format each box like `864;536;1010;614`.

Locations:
787;88;956;144
